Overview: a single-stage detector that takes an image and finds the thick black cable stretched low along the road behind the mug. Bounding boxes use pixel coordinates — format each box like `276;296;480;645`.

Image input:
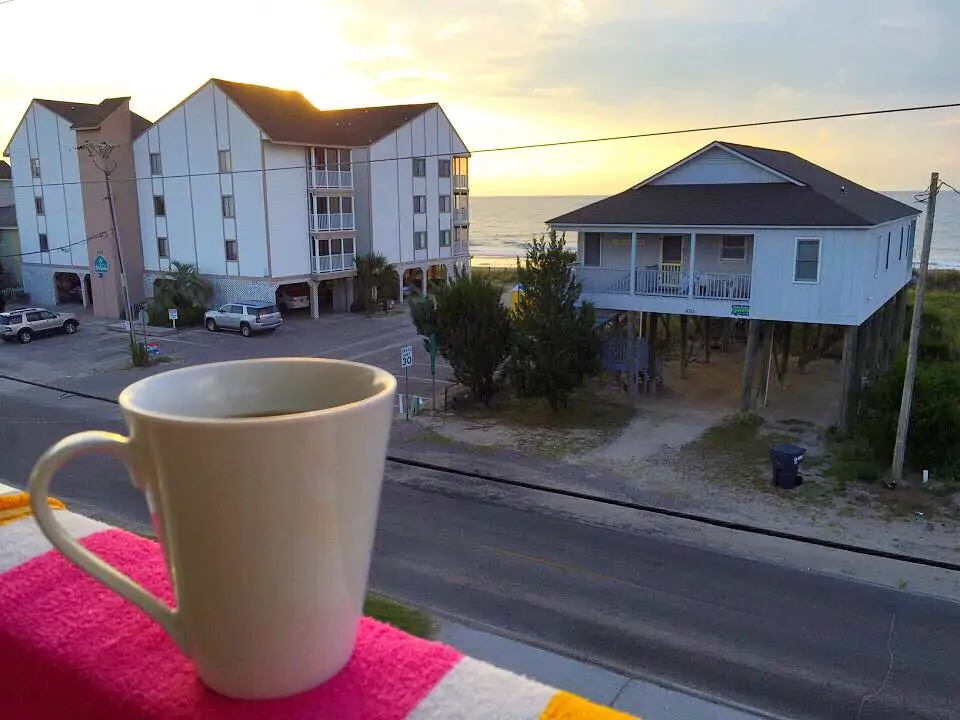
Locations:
0;373;960;572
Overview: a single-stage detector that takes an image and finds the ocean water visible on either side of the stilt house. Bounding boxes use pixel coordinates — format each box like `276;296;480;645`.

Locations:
470;187;960;268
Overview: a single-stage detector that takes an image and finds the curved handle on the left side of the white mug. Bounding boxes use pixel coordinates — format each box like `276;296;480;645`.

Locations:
28;430;186;652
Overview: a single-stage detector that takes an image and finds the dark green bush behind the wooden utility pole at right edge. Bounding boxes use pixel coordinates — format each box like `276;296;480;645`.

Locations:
857;359;960;473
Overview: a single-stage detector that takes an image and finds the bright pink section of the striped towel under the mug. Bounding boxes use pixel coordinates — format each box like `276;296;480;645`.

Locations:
0;530;461;720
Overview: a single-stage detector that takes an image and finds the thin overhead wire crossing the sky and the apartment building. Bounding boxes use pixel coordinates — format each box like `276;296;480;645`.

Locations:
8;100;960;190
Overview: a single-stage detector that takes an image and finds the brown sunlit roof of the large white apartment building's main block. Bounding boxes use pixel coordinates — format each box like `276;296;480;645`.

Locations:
212;78;437;147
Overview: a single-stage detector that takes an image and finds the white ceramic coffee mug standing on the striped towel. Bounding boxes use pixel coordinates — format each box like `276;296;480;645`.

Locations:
30;358;396;698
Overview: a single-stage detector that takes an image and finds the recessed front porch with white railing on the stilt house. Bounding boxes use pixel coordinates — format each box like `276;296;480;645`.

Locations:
577;232;754;317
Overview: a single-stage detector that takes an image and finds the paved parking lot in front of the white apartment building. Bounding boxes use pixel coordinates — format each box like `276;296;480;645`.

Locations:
0;309;452;410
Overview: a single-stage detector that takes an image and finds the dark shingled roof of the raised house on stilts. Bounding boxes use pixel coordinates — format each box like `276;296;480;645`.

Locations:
547;141;920;227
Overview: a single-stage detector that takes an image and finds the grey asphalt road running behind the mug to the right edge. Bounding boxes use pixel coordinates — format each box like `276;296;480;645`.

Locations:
0;383;960;720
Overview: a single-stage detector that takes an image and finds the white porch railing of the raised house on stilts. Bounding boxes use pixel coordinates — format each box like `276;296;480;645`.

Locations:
577;266;751;300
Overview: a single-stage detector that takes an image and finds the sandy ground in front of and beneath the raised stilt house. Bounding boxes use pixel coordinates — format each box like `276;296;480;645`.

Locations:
422;346;960;562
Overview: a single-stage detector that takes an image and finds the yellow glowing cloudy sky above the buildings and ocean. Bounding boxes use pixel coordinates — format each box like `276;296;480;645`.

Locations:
0;0;960;195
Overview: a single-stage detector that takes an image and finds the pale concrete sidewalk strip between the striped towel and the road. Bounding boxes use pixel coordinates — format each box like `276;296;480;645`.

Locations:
436;620;776;720
